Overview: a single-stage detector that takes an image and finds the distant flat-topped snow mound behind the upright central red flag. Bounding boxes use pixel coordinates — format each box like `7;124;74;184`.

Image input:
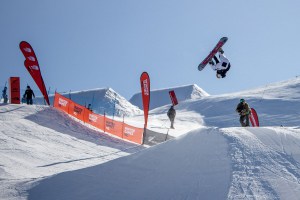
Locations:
129;84;209;110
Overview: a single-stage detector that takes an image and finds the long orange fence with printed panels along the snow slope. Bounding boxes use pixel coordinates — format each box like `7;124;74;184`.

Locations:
53;92;144;144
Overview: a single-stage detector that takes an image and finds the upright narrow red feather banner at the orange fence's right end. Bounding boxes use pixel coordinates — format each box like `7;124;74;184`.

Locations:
140;72;150;128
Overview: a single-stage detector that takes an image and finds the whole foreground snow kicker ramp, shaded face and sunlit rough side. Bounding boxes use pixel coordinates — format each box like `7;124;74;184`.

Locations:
29;127;300;200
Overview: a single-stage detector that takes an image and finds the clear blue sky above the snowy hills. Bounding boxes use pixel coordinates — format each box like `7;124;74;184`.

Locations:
0;0;300;99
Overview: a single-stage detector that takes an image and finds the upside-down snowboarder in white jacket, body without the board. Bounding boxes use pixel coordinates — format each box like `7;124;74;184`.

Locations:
209;48;230;78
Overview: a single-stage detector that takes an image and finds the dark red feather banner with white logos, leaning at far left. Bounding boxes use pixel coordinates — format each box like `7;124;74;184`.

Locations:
19;41;50;105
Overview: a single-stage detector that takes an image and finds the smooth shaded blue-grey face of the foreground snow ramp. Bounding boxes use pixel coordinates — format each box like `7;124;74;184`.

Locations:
29;129;231;200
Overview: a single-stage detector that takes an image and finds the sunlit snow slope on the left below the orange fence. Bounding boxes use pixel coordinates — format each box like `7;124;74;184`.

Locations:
0;105;143;200
